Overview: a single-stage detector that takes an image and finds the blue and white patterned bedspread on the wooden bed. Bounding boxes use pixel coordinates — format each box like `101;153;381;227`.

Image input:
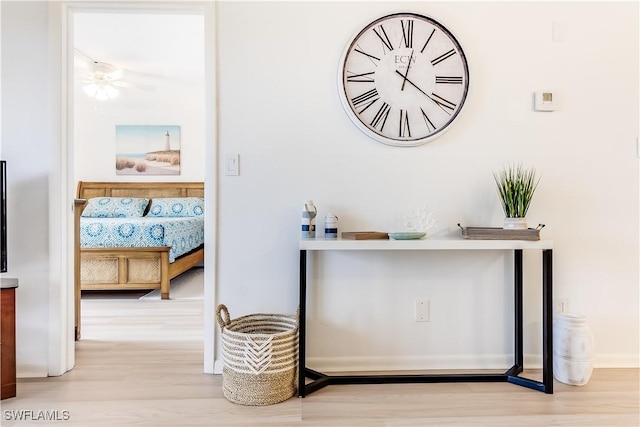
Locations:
80;217;204;262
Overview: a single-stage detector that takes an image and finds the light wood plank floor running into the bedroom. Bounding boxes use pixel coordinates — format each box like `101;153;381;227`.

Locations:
0;288;640;427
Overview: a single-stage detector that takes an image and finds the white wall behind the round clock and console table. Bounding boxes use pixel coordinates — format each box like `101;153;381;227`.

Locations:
218;2;639;369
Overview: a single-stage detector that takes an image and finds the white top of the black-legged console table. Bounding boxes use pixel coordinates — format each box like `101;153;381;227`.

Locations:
300;237;553;251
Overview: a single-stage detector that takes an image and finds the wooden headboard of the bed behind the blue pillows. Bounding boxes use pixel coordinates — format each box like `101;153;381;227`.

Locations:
76;181;204;199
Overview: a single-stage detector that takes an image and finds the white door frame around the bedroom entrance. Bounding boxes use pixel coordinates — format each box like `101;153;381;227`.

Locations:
48;0;218;376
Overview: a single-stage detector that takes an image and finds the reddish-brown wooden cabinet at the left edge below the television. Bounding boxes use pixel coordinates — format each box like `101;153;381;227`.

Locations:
0;279;18;399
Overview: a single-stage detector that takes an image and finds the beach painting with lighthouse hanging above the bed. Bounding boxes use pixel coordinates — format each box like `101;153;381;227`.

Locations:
116;125;180;175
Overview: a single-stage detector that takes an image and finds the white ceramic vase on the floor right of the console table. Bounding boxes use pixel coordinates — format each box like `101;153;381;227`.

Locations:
553;313;595;386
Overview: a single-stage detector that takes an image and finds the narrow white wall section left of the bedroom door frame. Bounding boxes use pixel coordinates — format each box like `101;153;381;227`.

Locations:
0;2;55;377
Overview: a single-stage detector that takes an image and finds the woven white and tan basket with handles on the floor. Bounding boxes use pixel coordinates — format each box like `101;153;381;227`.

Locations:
216;304;299;406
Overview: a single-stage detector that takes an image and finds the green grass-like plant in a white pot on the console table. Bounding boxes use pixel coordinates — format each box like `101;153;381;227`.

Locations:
493;165;540;229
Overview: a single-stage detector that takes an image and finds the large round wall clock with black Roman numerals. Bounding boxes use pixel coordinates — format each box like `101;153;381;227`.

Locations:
338;13;469;147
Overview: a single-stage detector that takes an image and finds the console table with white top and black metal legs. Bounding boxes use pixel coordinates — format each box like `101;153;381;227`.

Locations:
298;238;553;397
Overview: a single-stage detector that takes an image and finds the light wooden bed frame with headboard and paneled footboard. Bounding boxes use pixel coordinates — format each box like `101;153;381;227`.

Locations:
74;181;204;339
